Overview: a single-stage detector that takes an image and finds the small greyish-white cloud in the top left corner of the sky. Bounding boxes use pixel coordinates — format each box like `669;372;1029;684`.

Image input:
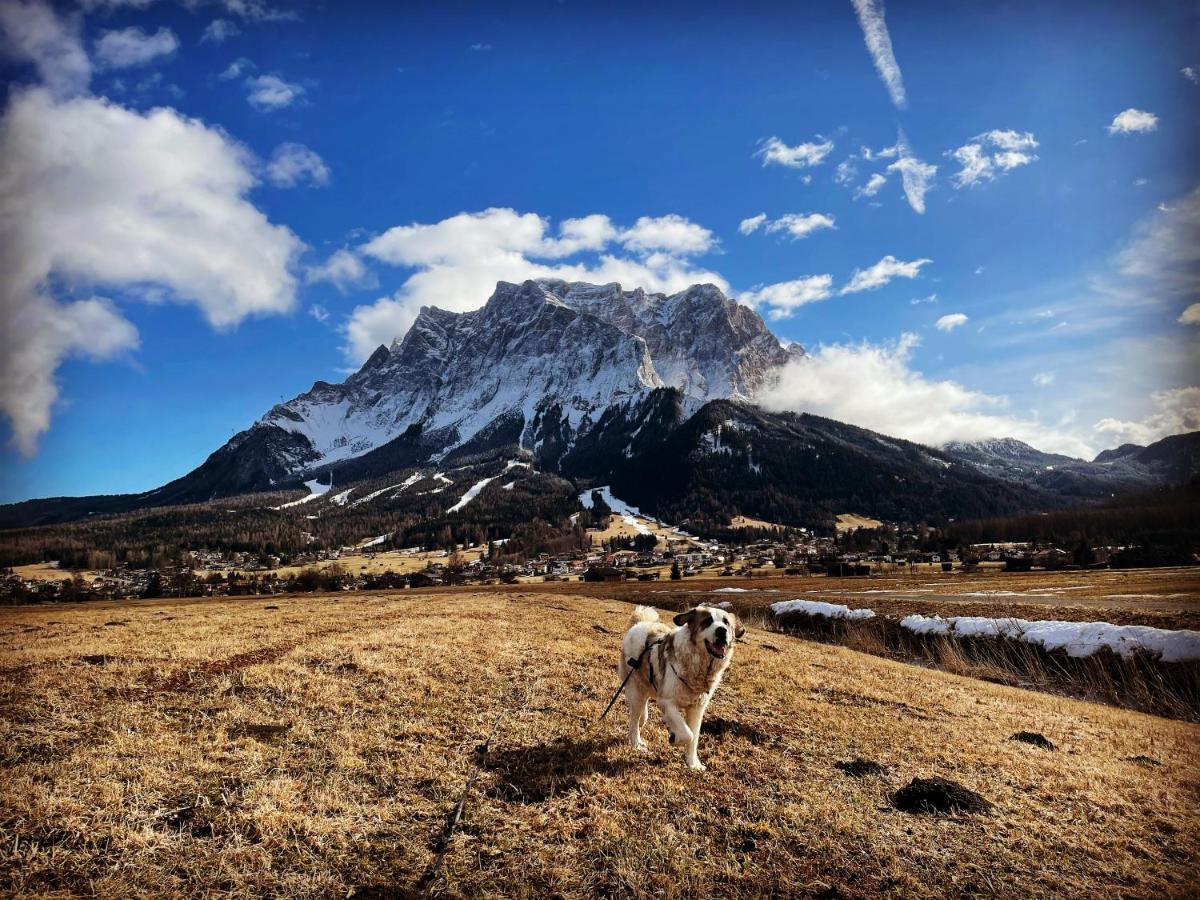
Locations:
0;0;91;97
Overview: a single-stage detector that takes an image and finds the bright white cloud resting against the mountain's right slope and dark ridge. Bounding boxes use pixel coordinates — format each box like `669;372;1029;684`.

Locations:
757;334;1092;457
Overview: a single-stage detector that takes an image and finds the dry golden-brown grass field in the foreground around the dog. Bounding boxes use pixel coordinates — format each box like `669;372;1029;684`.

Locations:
0;592;1200;898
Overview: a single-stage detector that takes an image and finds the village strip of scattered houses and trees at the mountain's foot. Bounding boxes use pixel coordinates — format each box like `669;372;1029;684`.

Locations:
0;504;1152;602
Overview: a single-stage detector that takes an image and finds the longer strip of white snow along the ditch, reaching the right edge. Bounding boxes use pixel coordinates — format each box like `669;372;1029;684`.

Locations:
900;614;1200;662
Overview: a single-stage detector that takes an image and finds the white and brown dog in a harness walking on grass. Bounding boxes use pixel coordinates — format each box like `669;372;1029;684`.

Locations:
617;606;745;772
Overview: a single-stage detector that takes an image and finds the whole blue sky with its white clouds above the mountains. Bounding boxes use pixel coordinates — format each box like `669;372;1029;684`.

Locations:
0;0;1200;500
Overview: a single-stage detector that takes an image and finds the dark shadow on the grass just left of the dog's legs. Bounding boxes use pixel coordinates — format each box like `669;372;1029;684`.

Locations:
482;738;634;804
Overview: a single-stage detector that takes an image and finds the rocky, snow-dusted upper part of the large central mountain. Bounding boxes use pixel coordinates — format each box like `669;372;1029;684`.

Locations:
187;280;804;490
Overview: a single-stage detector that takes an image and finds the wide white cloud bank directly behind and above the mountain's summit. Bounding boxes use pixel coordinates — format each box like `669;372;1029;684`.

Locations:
344;208;728;362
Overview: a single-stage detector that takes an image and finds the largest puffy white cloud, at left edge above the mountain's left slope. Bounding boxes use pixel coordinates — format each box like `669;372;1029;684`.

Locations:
0;89;302;454
